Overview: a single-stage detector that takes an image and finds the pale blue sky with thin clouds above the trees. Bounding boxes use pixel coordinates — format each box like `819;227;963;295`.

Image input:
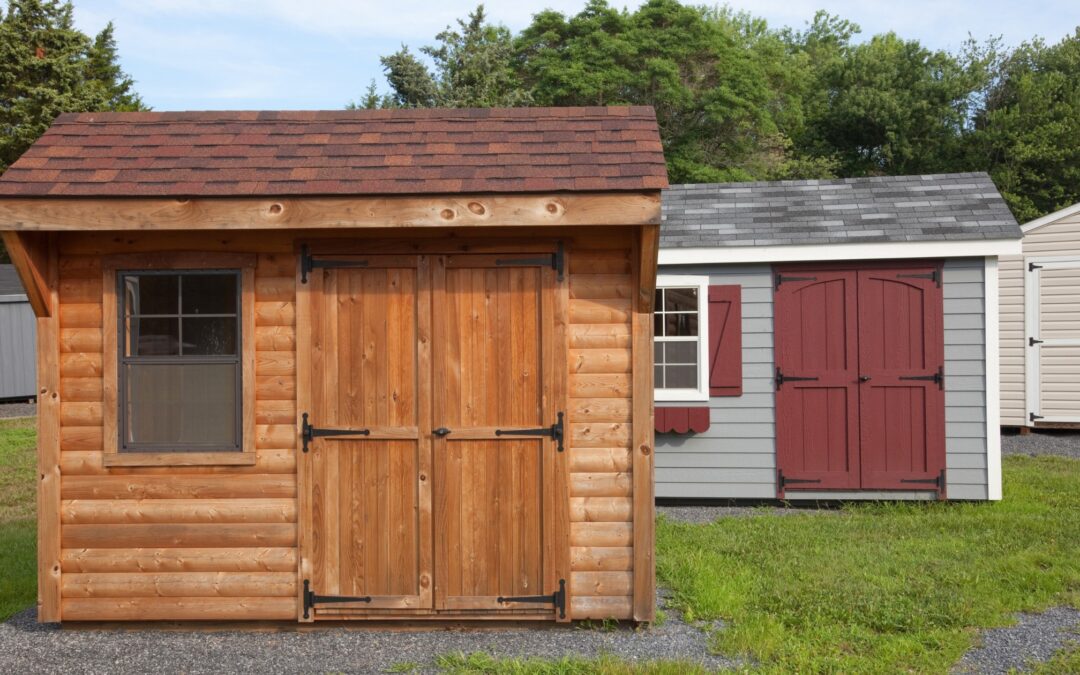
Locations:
75;0;1080;110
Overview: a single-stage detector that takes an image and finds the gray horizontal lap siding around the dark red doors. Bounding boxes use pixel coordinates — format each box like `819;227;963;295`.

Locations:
656;258;987;499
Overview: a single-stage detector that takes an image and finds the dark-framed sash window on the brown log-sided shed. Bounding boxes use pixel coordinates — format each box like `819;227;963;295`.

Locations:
118;270;243;453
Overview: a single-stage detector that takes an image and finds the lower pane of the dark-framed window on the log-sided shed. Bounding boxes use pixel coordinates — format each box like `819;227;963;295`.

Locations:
123;364;239;450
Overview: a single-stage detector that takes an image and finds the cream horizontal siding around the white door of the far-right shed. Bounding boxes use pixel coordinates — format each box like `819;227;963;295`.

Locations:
999;212;1080;427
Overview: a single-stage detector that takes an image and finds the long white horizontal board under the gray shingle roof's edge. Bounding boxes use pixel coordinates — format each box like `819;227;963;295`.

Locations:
660;239;1023;265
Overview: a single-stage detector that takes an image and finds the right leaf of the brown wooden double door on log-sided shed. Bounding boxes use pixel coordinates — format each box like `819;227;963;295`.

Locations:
432;255;559;613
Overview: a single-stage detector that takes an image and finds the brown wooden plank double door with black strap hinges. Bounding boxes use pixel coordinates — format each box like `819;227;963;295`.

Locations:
298;250;565;619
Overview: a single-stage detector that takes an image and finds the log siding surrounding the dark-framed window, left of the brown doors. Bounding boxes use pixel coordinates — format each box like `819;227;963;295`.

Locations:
59;243;297;620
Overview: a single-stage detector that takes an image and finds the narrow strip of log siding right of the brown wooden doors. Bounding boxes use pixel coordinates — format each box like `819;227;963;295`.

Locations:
567;248;634;619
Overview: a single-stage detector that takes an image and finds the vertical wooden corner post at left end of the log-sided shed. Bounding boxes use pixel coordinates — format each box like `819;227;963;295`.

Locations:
36;232;60;623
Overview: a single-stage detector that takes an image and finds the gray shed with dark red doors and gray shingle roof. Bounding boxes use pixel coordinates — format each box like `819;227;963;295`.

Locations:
656;174;1020;500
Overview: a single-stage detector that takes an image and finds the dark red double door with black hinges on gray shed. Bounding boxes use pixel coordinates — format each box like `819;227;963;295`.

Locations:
774;266;945;497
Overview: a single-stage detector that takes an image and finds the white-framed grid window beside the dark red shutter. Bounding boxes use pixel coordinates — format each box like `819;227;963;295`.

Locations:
652;274;708;401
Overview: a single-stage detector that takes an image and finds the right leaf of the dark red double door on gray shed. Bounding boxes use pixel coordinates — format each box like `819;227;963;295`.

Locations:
859;267;945;490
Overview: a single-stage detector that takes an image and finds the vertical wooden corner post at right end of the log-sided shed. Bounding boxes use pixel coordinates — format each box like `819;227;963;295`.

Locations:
632;225;660;621
